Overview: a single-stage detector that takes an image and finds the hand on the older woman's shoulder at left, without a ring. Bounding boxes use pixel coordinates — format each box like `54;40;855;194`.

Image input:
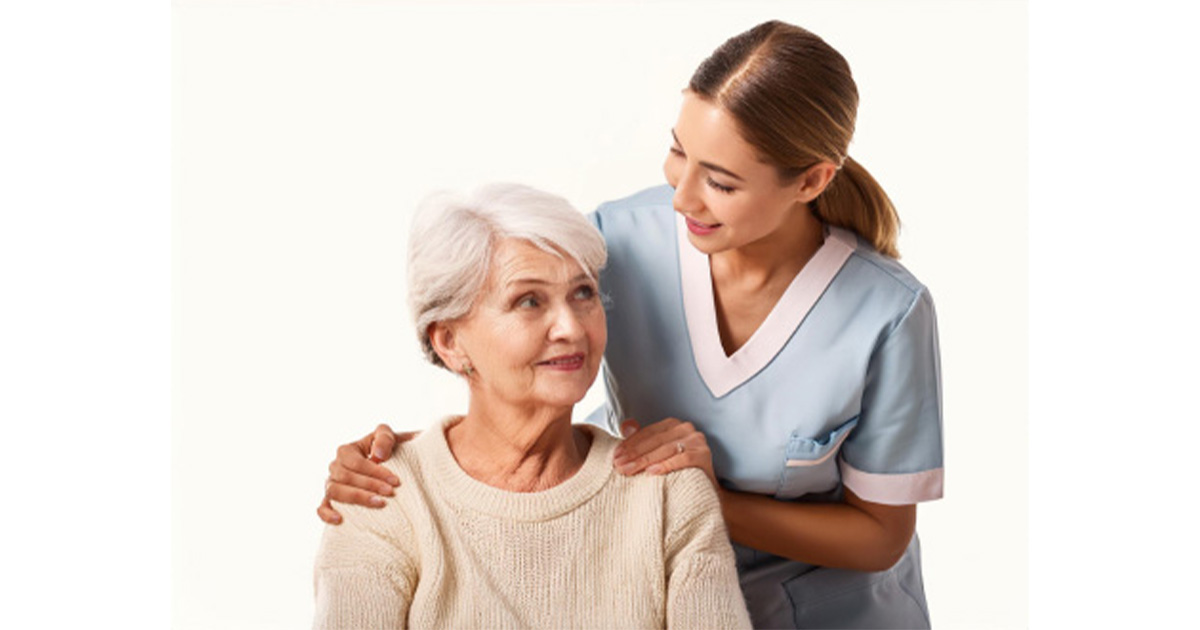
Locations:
317;425;416;524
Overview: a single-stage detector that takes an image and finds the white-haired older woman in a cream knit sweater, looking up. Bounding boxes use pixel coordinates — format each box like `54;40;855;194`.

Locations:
314;185;750;628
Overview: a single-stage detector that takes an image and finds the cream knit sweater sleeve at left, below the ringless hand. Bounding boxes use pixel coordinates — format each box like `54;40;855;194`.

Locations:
312;492;418;629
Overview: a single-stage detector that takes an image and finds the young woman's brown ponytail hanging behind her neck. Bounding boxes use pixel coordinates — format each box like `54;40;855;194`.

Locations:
811;156;900;258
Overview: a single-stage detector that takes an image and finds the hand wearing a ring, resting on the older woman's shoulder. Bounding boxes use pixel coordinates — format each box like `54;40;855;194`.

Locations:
612;418;720;490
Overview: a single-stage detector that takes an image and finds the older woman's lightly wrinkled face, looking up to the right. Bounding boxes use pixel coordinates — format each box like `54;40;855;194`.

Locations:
454;239;607;407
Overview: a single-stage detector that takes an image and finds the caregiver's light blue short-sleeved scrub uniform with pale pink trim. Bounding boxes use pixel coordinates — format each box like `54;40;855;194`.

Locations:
588;186;942;628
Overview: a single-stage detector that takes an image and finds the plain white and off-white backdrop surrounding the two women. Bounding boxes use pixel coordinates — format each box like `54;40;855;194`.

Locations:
0;0;1200;628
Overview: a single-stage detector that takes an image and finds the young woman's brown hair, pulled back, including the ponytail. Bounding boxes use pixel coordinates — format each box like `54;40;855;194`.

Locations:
688;20;900;258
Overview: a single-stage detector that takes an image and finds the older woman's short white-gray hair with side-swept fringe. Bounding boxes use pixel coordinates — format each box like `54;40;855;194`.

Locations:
408;184;608;367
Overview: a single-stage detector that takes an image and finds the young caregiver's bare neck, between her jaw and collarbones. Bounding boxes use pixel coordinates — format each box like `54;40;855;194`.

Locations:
709;206;824;284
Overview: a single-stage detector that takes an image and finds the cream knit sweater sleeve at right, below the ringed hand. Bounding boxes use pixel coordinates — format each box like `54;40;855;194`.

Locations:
666;468;750;629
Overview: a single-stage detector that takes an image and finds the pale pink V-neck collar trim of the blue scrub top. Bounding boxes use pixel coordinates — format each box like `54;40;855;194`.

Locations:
676;215;858;398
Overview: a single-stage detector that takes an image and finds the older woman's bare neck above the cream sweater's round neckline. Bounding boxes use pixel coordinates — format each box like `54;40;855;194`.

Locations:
446;395;590;492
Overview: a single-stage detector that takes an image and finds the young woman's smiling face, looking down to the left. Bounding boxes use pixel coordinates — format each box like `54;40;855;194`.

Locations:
662;92;803;254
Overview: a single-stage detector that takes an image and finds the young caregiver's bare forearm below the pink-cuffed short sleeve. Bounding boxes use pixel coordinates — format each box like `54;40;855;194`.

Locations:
720;490;916;571
